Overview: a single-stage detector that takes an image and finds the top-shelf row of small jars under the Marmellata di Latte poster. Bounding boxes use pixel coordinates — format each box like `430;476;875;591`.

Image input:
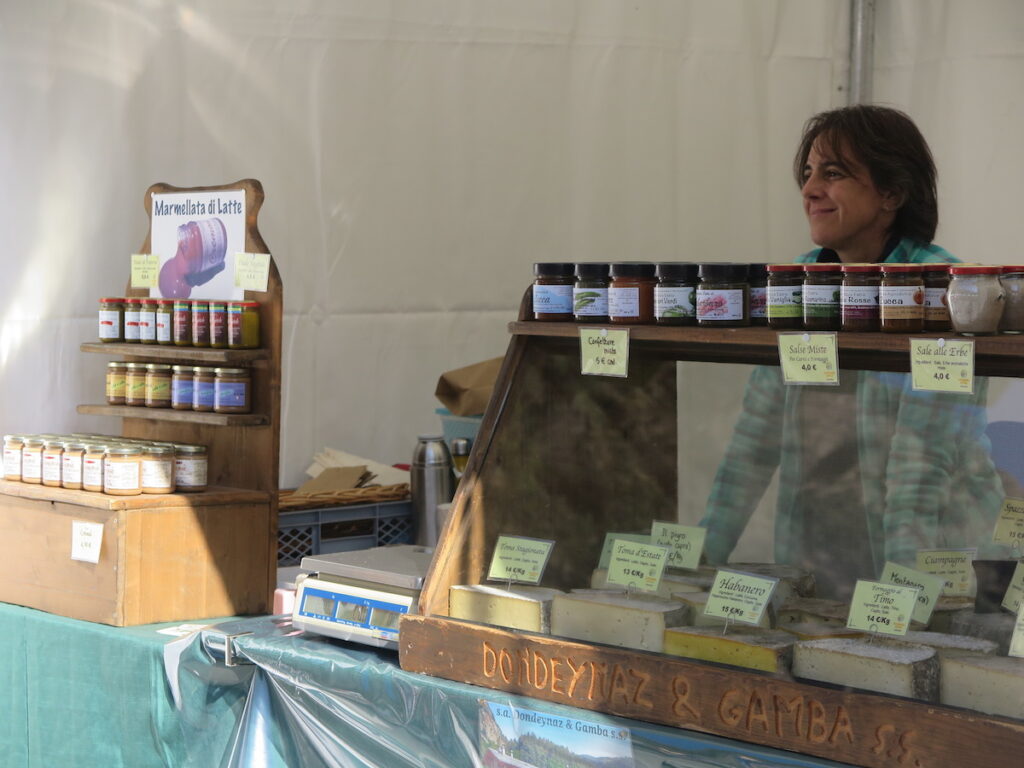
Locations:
99;297;260;349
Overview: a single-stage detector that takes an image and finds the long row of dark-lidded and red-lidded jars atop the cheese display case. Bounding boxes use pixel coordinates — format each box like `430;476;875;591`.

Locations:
532;262;1024;334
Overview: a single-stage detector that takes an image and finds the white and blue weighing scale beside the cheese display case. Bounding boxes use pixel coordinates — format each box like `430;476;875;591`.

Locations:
292;544;434;649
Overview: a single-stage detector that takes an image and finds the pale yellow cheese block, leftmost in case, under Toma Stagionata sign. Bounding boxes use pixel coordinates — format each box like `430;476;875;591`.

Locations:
449;584;562;634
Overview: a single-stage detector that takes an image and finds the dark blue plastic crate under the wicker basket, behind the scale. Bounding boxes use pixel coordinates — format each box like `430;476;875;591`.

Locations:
278;501;416;567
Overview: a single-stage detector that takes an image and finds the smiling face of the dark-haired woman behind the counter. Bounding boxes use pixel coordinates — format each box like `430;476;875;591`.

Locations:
801;141;896;263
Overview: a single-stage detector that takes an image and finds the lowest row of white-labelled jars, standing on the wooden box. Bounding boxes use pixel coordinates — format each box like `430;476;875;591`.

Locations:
3;434;209;496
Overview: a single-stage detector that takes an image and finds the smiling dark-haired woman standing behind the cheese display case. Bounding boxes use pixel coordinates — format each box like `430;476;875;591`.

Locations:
701;105;1004;599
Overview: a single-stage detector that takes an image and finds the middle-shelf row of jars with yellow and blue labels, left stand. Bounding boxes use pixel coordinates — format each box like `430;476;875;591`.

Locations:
106;362;252;414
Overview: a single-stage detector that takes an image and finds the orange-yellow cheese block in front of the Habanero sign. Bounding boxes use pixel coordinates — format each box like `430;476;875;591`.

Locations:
665;627;796;672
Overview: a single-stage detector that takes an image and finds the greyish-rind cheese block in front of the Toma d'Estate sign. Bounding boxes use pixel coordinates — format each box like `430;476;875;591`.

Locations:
551;592;686;652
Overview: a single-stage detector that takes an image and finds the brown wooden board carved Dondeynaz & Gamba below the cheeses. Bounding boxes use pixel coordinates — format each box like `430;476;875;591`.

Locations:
399;615;1024;768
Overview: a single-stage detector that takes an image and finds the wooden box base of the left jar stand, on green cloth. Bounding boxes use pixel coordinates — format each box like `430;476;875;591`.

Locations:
0;480;272;627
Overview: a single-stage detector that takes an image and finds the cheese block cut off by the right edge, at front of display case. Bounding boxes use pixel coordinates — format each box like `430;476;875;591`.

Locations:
939;655;1024;719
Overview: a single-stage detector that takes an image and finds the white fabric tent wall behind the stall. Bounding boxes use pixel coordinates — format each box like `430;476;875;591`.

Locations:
0;0;1024;486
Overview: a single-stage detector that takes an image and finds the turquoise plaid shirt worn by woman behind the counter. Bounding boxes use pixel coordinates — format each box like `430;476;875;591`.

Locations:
700;240;1004;573
